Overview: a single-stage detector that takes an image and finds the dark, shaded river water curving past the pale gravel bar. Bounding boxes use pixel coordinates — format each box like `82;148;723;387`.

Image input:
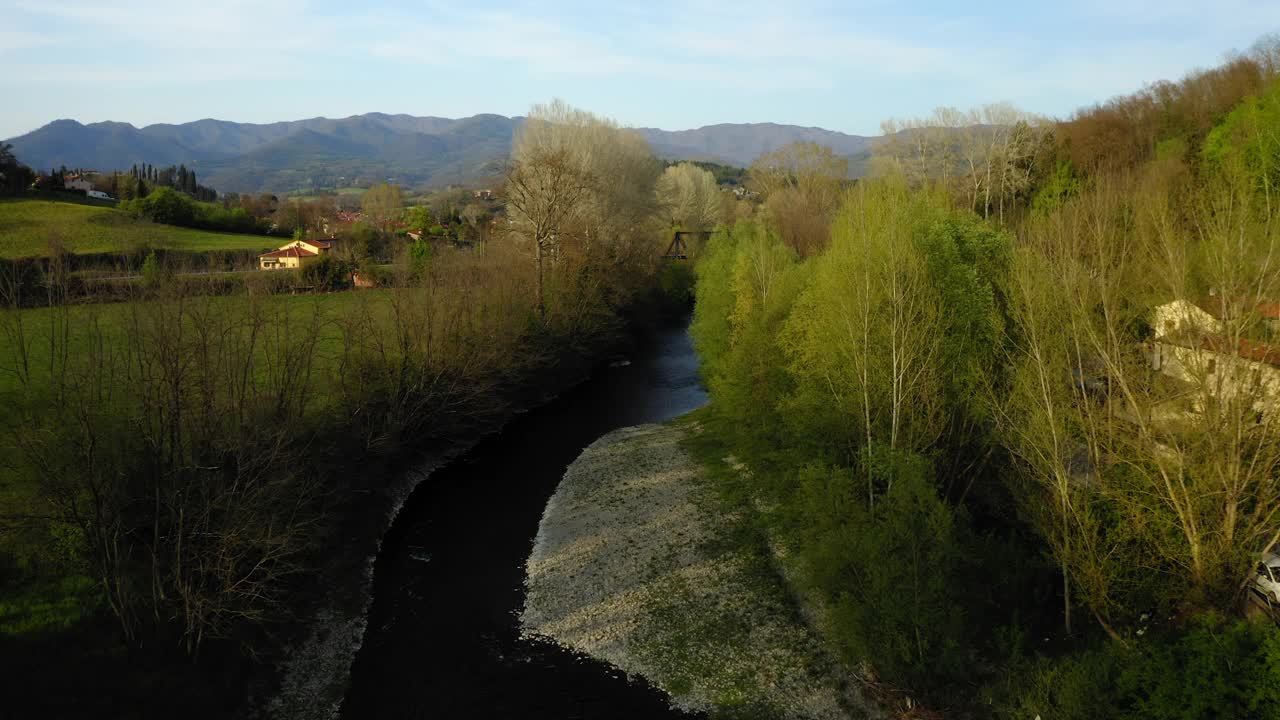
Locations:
343;317;707;719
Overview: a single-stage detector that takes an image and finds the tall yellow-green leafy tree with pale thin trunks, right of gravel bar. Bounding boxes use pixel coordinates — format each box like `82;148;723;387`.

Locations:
782;176;943;507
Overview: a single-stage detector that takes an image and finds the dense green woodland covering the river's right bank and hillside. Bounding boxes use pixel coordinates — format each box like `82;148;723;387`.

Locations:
692;33;1280;719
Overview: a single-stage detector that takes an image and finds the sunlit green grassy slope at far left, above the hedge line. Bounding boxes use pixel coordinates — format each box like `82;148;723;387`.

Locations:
0;199;282;259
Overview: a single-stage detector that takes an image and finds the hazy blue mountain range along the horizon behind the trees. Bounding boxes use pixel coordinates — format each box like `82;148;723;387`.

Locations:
6;113;873;192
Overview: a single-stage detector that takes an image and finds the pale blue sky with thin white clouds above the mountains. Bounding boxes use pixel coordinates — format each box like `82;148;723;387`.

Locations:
0;0;1280;137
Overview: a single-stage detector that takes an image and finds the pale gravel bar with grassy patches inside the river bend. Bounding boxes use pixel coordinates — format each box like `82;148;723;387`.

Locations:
521;423;868;719
